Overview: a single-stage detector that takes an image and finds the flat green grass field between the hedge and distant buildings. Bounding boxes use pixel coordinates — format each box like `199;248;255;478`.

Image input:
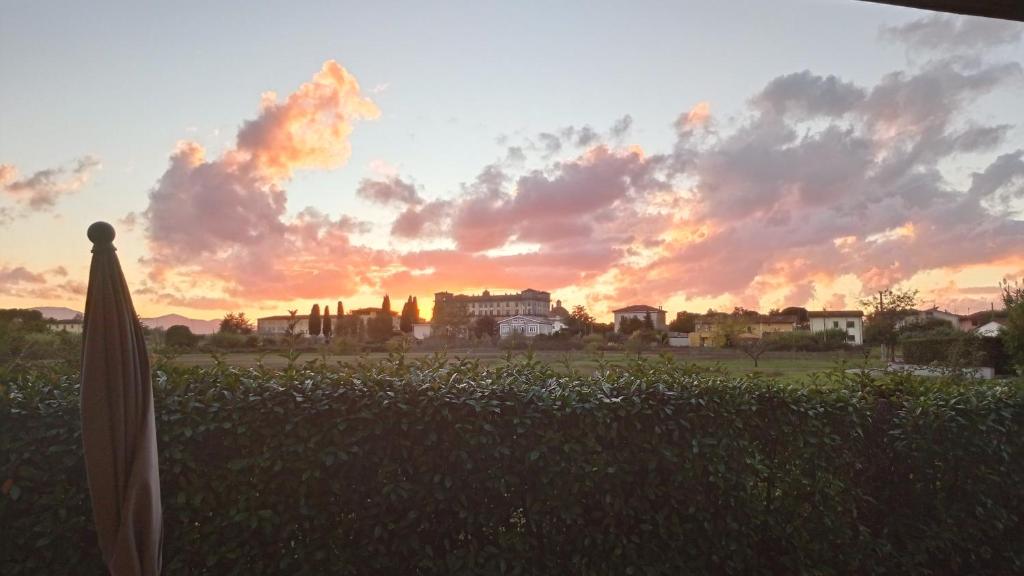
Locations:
165;348;883;381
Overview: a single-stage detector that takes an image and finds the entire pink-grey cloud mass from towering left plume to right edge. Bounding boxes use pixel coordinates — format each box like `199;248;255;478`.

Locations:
144;17;1024;313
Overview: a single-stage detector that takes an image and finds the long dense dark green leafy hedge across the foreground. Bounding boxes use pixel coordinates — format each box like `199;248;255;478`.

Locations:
6;357;1024;575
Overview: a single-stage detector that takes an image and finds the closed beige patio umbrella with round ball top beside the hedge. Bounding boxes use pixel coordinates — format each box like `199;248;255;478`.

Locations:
82;222;163;576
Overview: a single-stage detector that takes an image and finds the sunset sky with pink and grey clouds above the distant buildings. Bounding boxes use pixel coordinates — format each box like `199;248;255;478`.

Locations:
0;0;1024;320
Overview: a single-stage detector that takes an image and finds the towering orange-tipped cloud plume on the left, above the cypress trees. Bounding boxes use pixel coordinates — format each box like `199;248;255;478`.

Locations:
143;60;389;300
